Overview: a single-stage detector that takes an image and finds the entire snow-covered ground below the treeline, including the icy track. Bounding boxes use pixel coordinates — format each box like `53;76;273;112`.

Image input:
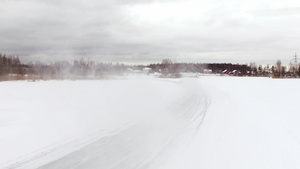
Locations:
0;76;300;169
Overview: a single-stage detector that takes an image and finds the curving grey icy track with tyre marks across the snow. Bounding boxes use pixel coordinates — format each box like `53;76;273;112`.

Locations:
5;79;210;169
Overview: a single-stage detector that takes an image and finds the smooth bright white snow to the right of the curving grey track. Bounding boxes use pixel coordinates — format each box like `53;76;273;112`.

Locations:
163;77;300;169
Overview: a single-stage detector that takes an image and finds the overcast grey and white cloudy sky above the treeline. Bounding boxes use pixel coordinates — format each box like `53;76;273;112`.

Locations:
0;0;300;64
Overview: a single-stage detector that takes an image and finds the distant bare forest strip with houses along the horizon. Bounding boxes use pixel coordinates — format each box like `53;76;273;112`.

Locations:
0;54;300;81
